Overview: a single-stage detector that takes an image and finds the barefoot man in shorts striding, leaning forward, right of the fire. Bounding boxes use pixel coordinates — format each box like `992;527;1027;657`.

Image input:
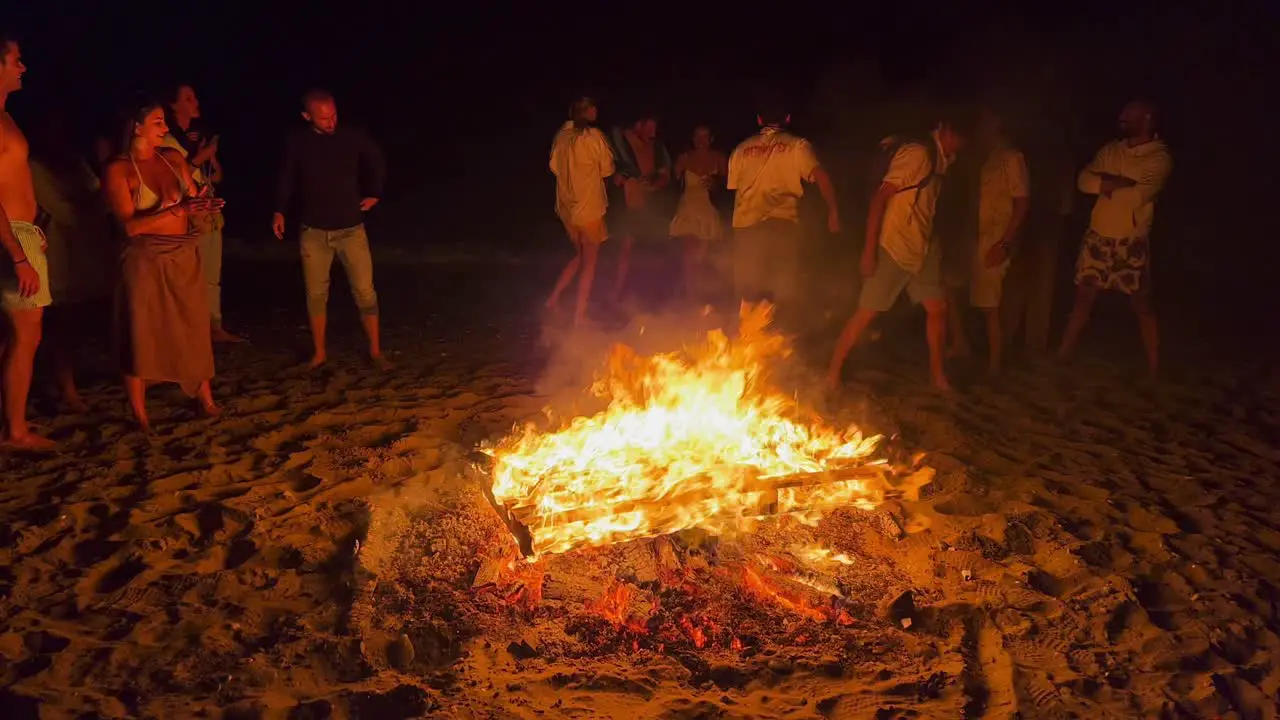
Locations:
827;116;964;391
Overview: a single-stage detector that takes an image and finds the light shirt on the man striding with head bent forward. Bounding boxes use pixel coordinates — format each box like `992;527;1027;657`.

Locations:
881;135;951;273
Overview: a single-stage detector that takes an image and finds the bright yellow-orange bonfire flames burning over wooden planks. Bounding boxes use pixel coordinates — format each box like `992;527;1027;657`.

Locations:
485;304;886;553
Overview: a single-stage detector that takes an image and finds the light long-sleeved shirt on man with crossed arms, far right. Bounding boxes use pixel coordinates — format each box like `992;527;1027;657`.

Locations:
1076;138;1174;237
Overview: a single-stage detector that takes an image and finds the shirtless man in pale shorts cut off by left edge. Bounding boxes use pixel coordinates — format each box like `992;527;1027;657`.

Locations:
0;36;54;450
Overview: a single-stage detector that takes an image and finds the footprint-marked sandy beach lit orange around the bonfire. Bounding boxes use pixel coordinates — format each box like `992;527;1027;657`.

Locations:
0;248;1280;720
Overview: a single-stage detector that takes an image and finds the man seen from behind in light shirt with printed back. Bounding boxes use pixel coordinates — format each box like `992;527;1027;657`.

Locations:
726;99;840;310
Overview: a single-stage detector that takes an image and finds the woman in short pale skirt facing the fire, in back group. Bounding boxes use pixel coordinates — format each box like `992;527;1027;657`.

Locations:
669;126;728;297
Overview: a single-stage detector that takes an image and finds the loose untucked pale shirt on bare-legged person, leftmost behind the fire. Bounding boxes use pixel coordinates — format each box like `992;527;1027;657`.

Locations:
550;122;613;227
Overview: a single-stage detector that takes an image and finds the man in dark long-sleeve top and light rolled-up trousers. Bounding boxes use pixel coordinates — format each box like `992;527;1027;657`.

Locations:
271;90;388;368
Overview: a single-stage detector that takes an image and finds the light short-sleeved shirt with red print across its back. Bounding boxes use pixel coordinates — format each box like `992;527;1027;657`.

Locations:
726;127;818;228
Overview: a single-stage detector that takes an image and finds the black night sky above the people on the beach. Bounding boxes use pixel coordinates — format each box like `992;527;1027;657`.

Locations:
6;0;1277;307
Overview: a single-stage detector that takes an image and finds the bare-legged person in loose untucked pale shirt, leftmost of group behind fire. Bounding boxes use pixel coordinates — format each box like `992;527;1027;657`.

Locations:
547;97;613;325
